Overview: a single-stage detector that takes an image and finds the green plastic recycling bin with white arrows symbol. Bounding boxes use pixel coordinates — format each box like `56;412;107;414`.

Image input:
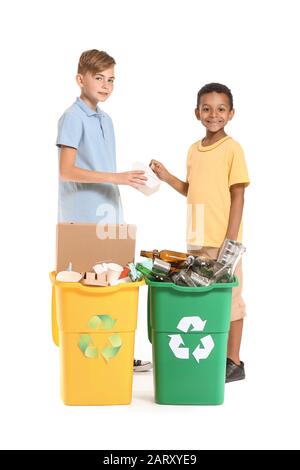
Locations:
146;278;238;405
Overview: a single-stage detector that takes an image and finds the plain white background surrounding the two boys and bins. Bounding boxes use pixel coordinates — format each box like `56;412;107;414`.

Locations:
0;0;300;449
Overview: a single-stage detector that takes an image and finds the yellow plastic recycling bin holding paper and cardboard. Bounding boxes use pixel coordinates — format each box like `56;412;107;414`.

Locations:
50;273;144;405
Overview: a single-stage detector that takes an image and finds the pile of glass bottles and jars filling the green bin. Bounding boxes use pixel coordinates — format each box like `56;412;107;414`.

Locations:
129;239;246;287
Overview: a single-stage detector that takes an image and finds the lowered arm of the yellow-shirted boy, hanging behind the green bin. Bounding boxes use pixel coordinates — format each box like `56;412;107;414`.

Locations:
225;184;245;240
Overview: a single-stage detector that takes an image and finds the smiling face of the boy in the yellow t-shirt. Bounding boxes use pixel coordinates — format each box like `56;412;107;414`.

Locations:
195;91;234;133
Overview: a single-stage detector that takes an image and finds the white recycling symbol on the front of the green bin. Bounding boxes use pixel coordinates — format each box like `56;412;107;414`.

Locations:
168;317;215;364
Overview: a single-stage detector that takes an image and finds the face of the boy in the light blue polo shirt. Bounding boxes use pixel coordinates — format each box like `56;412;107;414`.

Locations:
76;67;115;107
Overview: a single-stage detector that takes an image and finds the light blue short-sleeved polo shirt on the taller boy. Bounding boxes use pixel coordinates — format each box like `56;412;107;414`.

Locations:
56;98;124;224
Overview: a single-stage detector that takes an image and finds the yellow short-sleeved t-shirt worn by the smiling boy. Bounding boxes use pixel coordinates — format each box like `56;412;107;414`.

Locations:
187;136;250;249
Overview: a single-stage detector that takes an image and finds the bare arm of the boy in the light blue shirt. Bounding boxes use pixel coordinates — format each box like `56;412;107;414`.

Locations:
59;145;147;188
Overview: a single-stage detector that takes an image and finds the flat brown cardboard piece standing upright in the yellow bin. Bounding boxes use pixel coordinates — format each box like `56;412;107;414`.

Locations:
56;223;136;273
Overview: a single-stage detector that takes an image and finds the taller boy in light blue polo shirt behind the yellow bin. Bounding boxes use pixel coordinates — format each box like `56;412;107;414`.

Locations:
56;49;151;371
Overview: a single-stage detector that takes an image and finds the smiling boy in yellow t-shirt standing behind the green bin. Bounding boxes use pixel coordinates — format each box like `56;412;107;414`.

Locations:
150;83;249;382
